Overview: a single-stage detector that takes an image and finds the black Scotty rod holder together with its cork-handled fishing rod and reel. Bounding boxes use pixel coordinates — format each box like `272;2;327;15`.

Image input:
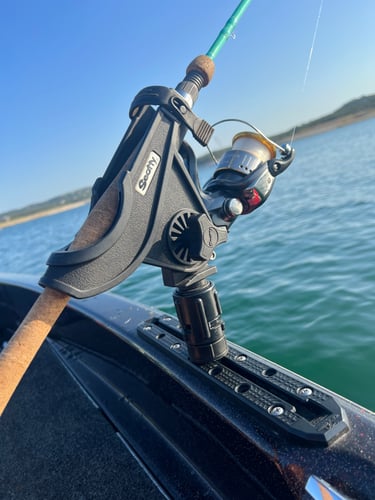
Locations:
0;0;293;414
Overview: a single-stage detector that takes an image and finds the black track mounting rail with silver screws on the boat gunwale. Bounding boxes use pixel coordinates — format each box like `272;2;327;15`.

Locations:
138;317;349;446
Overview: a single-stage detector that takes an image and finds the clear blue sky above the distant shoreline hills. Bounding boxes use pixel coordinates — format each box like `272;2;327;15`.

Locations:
0;0;375;213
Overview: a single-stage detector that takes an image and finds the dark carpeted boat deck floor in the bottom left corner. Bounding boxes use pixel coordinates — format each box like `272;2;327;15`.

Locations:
0;343;165;500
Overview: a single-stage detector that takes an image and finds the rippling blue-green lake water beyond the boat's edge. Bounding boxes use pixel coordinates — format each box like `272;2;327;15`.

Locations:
0;120;375;410
